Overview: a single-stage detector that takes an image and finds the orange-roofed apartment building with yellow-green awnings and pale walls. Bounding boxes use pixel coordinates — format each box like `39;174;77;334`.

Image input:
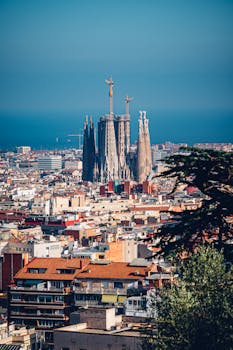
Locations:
73;259;156;313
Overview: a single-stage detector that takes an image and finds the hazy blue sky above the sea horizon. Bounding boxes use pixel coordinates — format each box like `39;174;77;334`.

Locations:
0;0;233;112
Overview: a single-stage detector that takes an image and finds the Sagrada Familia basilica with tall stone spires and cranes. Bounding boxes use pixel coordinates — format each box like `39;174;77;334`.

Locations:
82;77;152;183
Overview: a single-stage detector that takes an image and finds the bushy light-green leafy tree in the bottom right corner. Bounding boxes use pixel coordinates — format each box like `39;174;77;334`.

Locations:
143;246;233;350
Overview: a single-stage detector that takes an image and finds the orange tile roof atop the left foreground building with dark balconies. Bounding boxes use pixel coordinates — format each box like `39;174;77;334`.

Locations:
14;258;90;281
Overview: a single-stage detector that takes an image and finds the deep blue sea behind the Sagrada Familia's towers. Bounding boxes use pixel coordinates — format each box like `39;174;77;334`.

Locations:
0;109;233;151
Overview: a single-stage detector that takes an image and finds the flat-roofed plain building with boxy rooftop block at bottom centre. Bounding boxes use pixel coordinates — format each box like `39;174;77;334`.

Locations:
54;307;143;350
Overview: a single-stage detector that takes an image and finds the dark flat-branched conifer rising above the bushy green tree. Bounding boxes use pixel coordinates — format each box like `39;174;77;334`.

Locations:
156;147;233;259
